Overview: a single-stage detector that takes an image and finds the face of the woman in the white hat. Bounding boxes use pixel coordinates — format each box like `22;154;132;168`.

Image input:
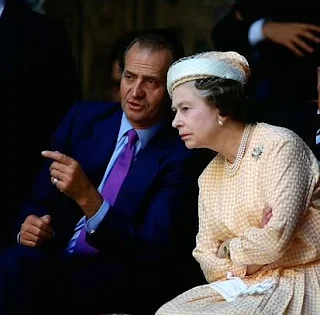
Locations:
172;83;219;149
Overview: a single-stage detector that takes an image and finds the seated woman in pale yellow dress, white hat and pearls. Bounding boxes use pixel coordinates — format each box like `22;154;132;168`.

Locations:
156;52;320;315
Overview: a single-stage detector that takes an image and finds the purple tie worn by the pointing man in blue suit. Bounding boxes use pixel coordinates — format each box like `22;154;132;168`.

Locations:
73;129;139;255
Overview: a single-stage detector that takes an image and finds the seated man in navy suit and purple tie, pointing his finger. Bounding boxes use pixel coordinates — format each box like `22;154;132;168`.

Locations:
0;30;212;314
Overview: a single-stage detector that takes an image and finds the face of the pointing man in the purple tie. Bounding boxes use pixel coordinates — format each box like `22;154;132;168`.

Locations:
120;43;172;129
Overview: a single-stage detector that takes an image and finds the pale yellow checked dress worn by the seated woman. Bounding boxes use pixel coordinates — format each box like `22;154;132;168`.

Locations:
156;123;320;315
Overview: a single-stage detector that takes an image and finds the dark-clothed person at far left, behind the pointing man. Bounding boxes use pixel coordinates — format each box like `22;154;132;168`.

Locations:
0;0;79;248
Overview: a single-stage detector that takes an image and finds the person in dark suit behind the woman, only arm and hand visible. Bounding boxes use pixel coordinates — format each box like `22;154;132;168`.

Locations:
211;0;320;150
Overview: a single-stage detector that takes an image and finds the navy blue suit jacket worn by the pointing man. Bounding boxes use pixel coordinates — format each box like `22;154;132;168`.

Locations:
20;102;212;276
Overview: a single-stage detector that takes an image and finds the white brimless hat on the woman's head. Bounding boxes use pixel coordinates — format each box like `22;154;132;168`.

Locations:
167;51;250;97
